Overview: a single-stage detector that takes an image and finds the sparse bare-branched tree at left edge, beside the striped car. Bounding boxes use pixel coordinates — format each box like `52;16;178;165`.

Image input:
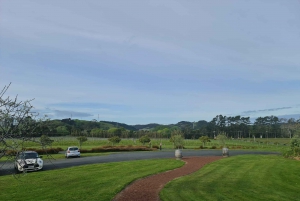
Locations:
0;84;48;174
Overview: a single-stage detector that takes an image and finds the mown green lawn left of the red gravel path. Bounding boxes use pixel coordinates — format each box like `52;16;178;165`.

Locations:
0;159;184;201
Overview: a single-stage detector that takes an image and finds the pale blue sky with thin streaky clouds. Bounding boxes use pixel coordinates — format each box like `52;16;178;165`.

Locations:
0;0;300;125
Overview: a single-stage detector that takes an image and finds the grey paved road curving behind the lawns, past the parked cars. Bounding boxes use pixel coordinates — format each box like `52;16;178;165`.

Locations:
0;150;278;176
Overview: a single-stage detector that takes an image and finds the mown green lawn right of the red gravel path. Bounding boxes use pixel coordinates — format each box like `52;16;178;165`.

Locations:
160;155;300;201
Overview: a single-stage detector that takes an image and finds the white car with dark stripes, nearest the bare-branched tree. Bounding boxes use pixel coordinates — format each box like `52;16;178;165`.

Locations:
15;151;44;172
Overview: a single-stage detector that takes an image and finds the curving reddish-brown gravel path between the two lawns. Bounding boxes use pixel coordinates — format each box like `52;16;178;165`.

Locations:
113;156;223;201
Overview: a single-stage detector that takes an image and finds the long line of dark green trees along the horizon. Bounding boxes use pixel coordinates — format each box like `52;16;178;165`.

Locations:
21;115;300;139
